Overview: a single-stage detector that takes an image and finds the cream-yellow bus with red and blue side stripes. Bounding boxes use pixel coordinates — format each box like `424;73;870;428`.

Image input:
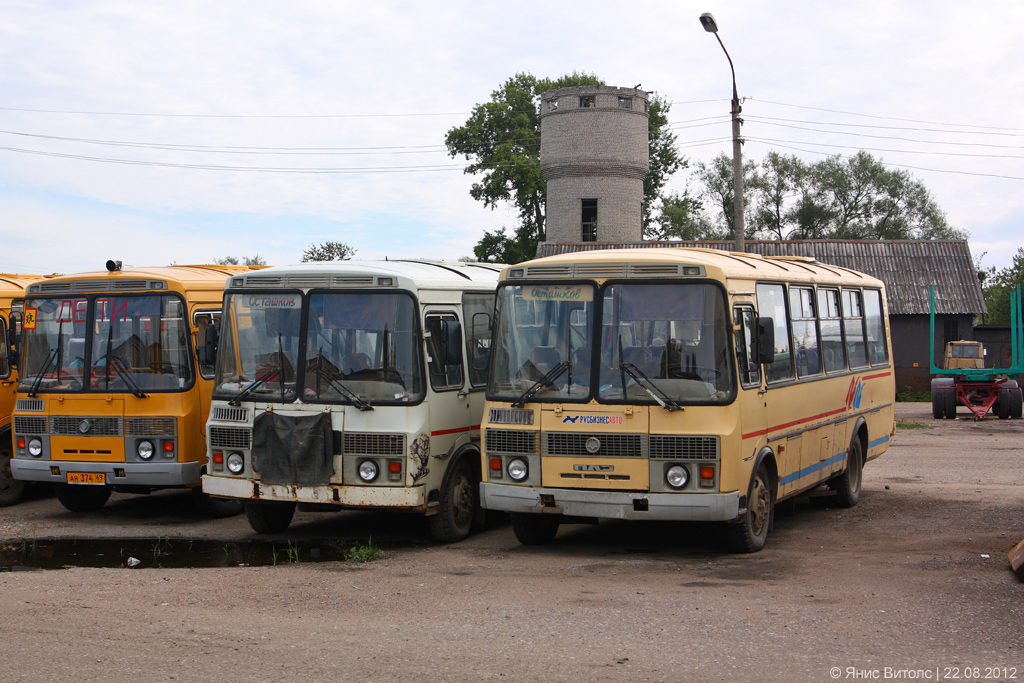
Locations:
480;249;895;552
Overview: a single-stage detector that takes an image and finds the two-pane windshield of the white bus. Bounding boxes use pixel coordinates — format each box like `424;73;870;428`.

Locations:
215;291;424;409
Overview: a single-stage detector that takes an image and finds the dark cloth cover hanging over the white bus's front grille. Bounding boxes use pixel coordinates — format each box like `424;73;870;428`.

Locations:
253;413;334;486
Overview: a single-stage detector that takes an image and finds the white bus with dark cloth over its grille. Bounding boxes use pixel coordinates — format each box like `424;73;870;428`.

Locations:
203;261;502;542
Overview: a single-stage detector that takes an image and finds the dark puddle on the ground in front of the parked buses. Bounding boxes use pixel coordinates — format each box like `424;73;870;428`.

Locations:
0;537;380;571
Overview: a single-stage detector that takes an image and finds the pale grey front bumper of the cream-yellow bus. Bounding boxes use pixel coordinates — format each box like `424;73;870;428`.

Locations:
480;482;739;521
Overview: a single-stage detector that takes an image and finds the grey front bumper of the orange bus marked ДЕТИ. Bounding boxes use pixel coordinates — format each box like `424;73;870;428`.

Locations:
10;458;200;488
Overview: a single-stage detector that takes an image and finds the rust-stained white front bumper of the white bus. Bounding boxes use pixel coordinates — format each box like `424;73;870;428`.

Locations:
203;474;427;512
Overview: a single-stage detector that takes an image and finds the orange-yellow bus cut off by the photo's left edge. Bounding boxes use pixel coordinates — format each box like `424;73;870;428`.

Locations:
0;273;49;507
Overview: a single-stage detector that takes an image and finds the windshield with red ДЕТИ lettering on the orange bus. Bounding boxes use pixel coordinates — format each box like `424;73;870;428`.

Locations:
19;295;193;395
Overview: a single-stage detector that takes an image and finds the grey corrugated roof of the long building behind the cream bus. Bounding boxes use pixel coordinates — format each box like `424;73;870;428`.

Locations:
537;240;988;315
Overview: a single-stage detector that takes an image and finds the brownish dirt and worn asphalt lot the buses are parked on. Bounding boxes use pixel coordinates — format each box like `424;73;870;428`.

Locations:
0;403;1024;681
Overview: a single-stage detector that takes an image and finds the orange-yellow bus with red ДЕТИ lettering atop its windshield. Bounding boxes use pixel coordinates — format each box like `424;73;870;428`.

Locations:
11;261;249;516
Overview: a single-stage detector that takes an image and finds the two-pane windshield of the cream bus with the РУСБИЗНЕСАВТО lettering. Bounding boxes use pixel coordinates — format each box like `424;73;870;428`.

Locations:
487;282;735;403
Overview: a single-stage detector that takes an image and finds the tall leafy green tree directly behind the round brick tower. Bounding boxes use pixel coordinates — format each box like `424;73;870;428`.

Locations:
444;72;686;263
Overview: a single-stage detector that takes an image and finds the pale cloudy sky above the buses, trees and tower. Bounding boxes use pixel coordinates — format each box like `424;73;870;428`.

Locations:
0;0;1024;272
